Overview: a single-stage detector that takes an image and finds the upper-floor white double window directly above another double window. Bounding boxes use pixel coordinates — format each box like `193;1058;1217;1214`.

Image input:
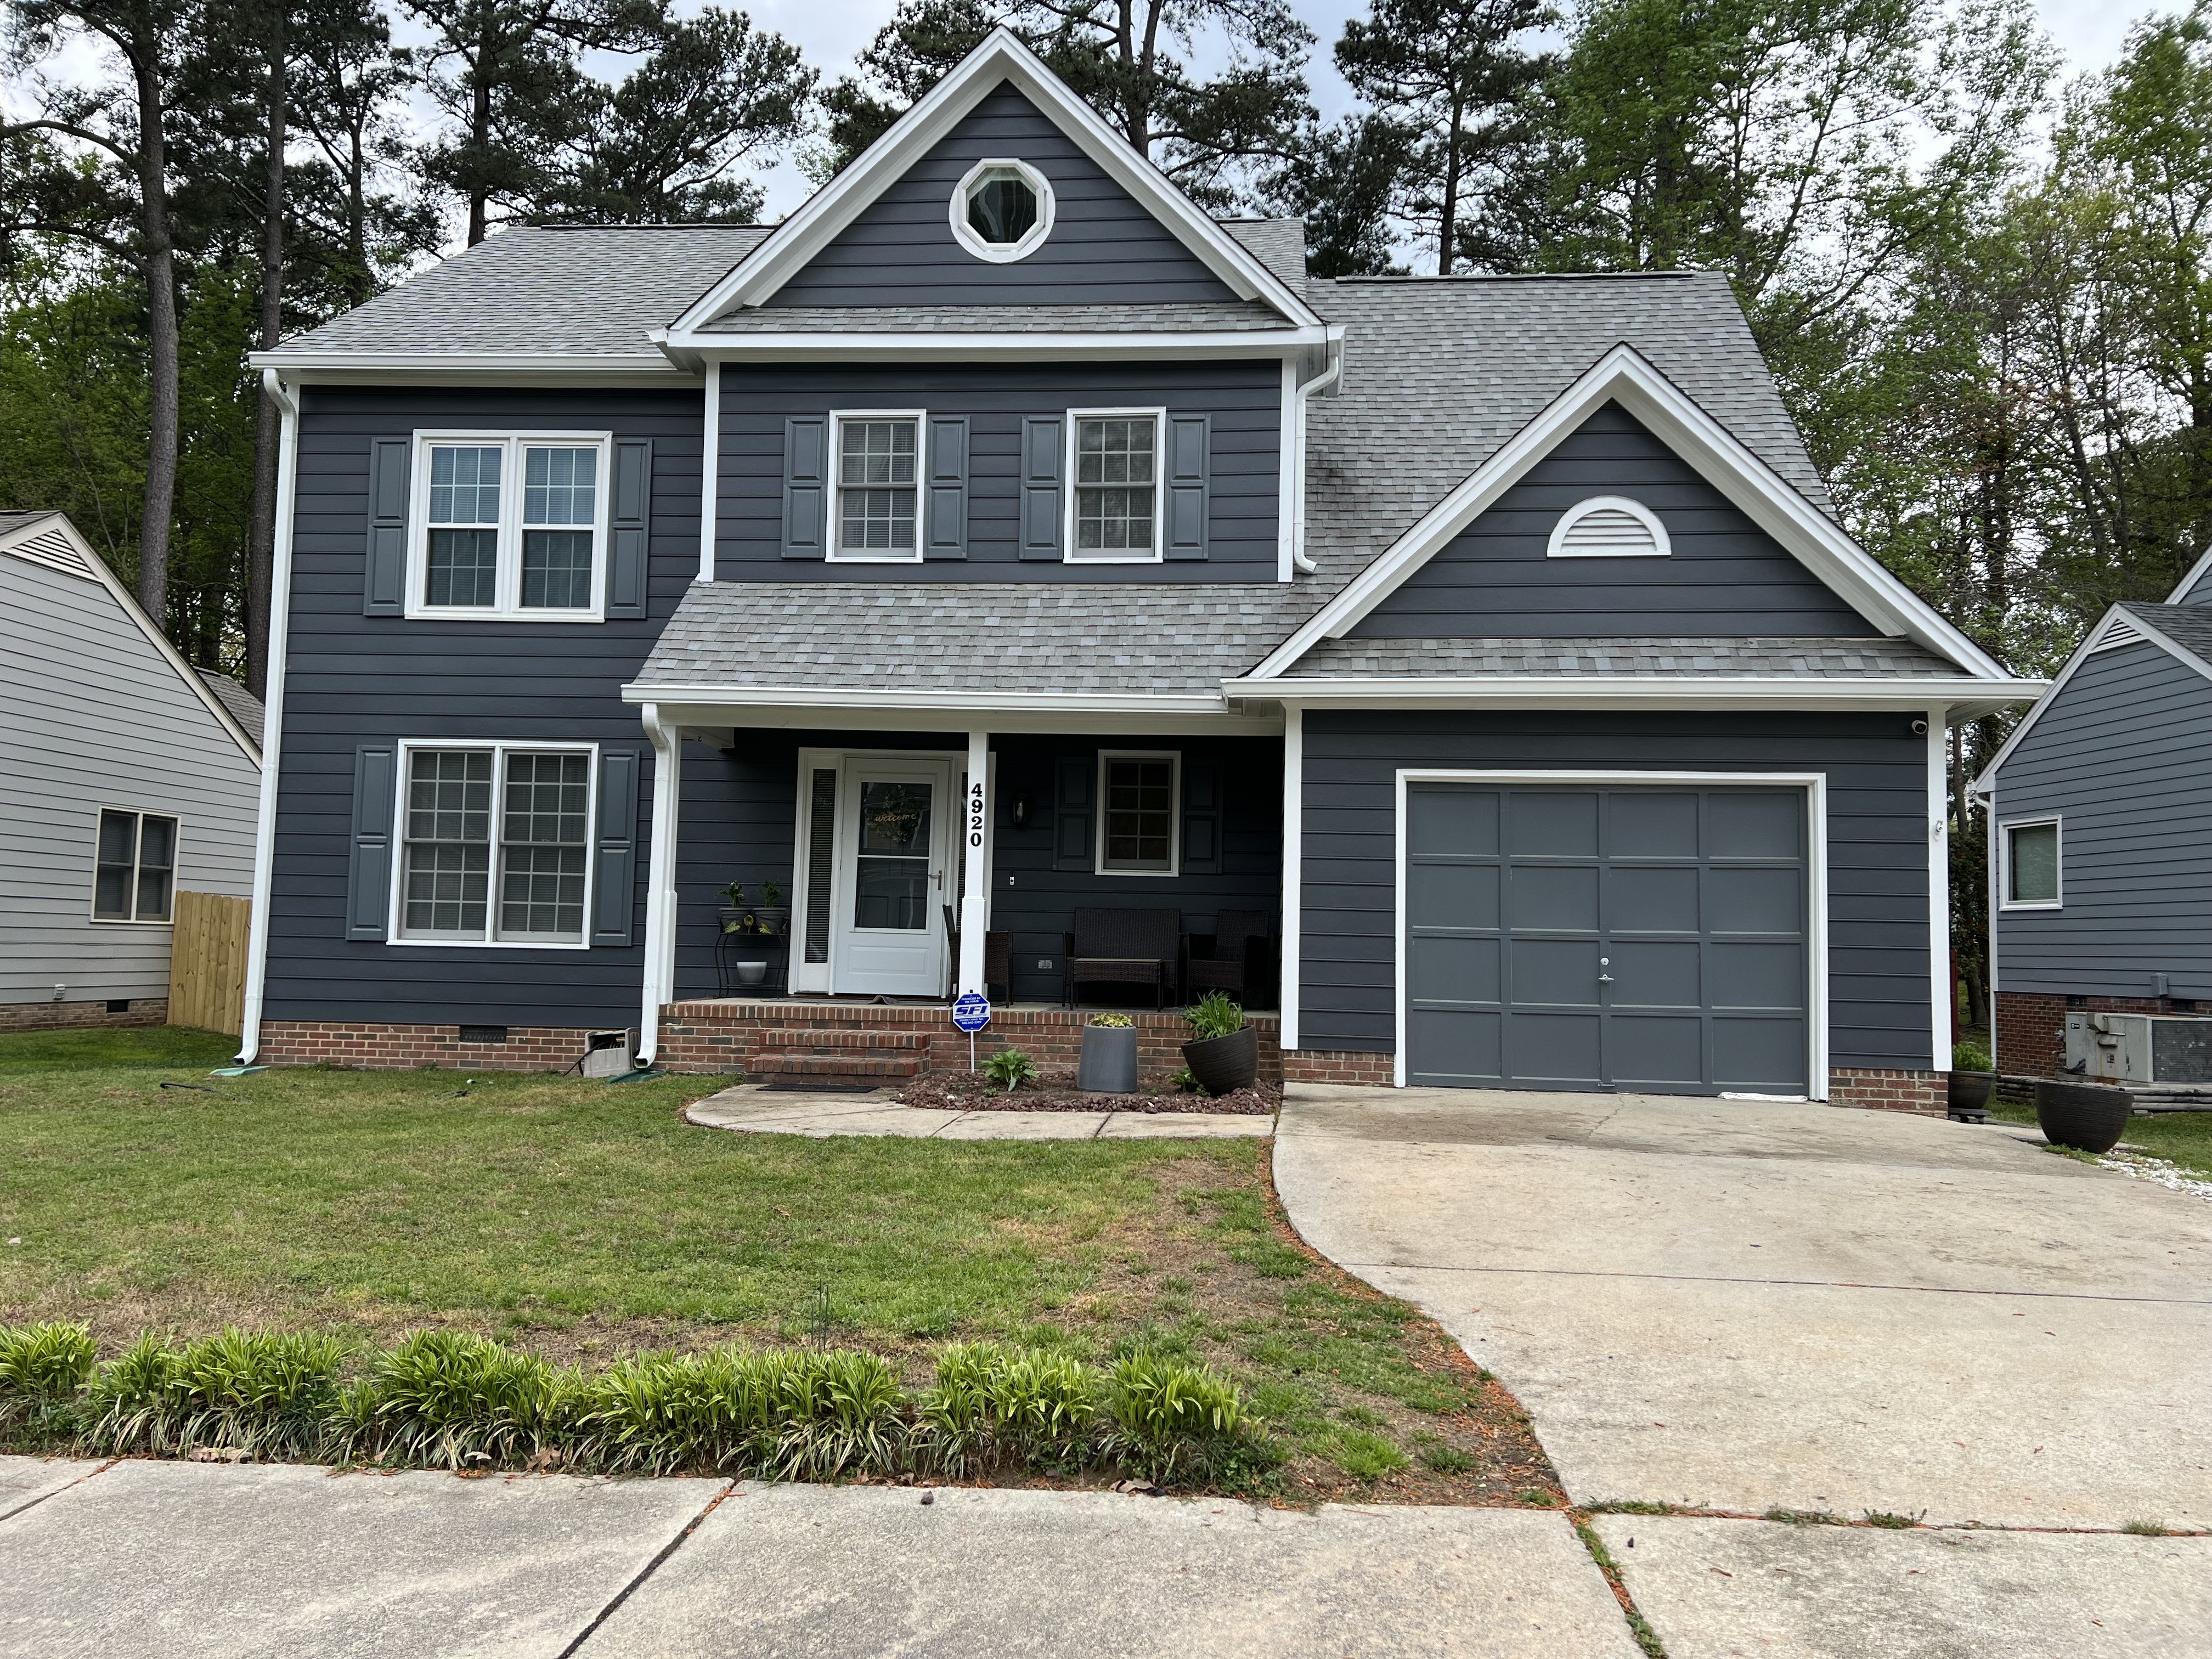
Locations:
407;431;608;622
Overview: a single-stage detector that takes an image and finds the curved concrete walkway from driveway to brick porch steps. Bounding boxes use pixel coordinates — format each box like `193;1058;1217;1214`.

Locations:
684;1084;1274;1142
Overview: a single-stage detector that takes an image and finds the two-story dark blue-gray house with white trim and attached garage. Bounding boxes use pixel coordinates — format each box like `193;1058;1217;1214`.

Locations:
238;33;2037;1106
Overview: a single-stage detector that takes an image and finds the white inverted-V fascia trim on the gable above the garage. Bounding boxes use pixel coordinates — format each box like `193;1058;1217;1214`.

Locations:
1254;345;2011;681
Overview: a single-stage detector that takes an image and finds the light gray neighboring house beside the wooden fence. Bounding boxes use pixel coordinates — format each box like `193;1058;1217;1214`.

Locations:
0;513;261;1031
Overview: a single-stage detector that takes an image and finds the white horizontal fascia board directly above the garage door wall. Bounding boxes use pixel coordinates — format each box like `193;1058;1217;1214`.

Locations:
1221;675;2044;710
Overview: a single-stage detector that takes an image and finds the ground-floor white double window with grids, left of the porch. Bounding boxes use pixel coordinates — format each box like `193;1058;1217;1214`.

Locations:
394;743;595;947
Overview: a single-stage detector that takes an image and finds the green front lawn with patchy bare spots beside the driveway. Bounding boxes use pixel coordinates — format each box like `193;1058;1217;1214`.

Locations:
0;1031;1553;1502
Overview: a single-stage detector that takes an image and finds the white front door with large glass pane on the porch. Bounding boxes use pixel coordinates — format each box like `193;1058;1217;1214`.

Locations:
830;757;953;997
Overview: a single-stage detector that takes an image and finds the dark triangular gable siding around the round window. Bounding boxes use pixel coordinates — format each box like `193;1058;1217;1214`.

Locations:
768;82;1237;305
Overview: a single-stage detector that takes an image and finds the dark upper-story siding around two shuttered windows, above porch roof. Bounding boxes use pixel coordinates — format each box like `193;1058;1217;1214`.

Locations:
714;363;1283;582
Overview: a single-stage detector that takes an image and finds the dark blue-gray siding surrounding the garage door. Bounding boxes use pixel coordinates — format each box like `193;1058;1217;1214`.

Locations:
1299;710;1931;1070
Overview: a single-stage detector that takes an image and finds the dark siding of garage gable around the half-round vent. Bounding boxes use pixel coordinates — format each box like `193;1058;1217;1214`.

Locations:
1352;403;1880;639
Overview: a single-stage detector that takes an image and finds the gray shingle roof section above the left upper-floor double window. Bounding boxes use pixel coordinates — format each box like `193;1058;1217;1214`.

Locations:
276;225;768;356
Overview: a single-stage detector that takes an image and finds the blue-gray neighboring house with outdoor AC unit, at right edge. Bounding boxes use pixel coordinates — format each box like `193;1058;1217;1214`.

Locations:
1973;553;2212;1082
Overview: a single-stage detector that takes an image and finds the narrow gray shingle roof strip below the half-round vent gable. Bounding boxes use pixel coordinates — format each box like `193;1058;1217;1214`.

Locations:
1292;639;1964;679
